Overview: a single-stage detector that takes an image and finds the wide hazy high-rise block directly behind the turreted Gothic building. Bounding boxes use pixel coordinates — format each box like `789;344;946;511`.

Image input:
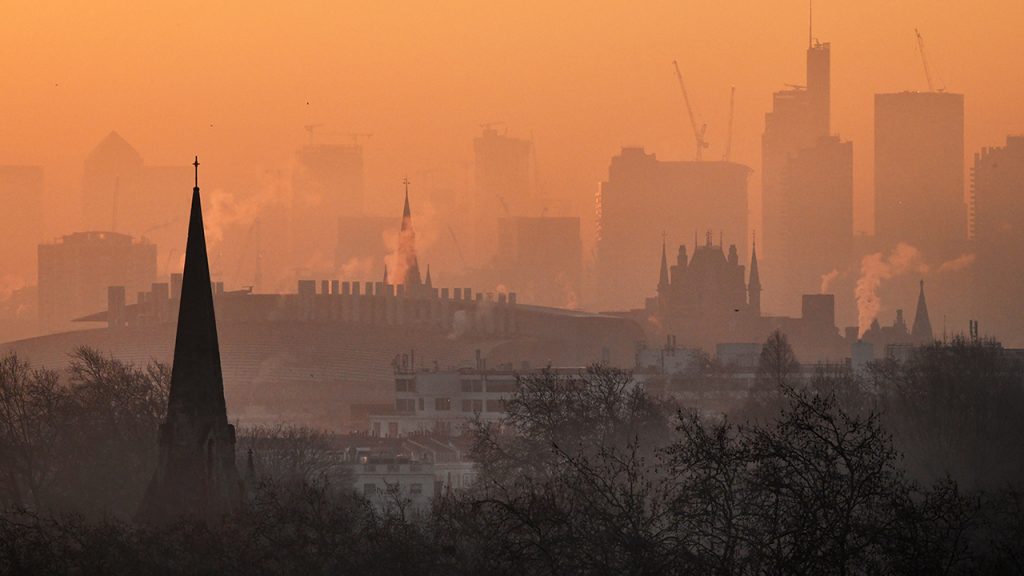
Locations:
594;148;751;310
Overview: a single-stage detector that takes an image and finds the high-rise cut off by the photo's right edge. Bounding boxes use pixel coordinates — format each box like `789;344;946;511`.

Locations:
971;136;1024;346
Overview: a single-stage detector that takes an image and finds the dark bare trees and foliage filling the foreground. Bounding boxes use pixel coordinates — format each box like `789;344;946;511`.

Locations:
0;337;1024;576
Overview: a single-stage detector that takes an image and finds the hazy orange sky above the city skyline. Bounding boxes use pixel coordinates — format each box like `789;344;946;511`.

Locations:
0;0;1024;240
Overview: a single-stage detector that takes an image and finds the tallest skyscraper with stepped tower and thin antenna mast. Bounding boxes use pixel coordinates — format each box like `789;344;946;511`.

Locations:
761;41;853;312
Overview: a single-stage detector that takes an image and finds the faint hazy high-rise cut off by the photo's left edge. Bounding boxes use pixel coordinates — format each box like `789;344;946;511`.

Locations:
0;166;43;280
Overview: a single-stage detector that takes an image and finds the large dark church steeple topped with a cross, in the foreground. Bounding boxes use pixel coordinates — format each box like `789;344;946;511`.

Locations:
139;158;242;523
